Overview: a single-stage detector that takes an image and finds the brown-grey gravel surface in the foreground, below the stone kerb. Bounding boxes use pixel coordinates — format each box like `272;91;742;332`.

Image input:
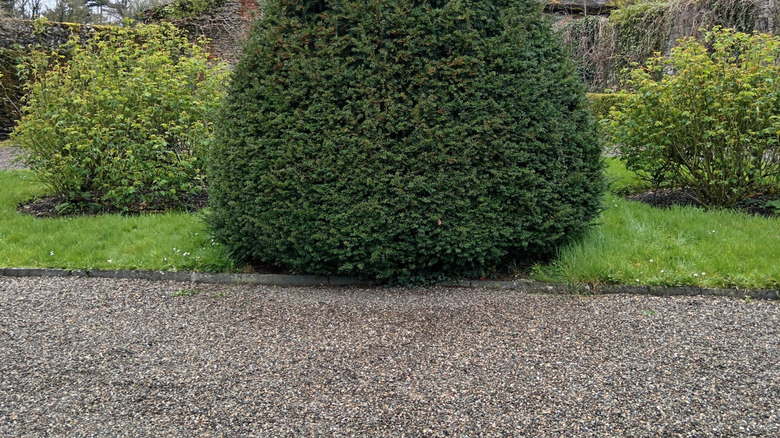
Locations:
0;277;780;437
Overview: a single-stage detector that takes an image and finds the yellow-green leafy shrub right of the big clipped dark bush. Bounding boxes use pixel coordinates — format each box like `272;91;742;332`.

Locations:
610;28;780;207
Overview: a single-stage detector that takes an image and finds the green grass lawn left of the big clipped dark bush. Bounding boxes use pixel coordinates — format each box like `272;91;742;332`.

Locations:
0;171;234;271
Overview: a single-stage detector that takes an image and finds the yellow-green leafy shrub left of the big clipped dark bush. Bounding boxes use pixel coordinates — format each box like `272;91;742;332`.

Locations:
13;25;228;211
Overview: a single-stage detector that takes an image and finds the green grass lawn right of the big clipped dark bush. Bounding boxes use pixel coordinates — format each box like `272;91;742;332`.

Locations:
536;159;780;289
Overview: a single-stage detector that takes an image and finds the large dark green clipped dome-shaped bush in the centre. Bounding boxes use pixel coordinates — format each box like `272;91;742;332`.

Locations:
209;0;604;281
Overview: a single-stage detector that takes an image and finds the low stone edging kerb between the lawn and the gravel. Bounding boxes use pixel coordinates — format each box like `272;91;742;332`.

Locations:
0;268;780;300
